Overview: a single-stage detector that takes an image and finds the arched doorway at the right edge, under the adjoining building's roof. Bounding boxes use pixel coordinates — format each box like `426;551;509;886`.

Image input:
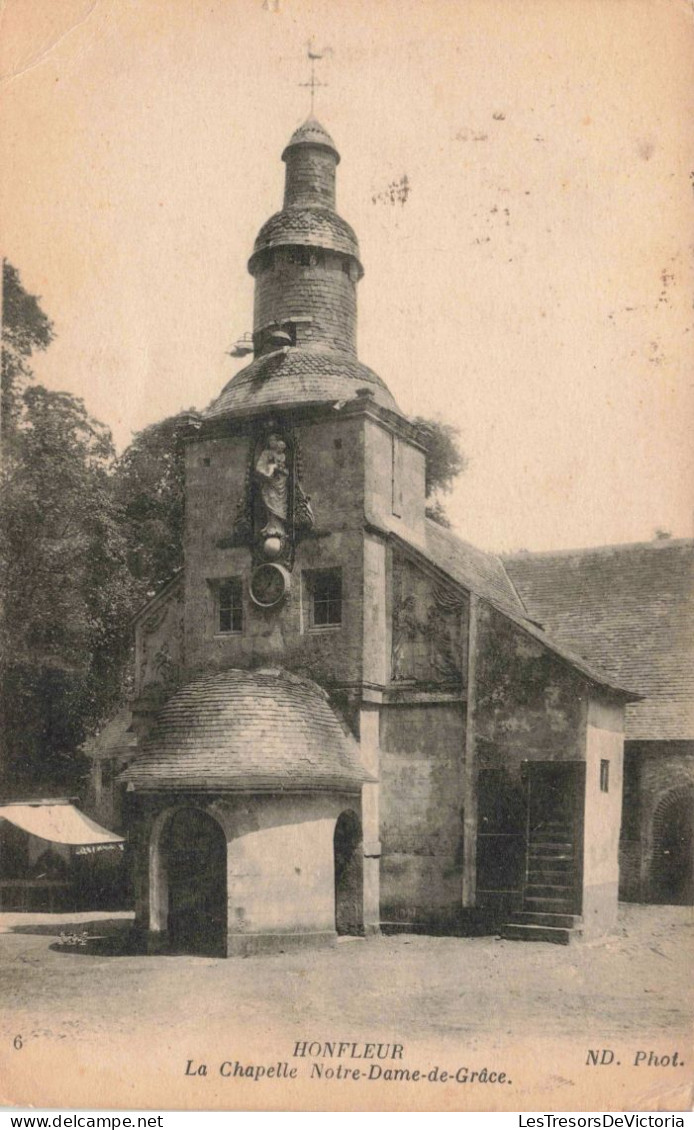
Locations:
651;789;694;906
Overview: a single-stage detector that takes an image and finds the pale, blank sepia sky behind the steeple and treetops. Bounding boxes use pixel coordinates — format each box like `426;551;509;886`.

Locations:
0;0;694;551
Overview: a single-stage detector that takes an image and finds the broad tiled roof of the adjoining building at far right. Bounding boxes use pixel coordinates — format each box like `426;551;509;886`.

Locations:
504;539;694;740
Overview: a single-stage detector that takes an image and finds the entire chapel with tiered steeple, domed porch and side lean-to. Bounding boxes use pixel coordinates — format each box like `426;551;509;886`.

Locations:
123;118;637;955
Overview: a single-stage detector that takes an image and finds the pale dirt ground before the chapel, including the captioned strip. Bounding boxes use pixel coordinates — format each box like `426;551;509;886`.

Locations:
0;906;694;1110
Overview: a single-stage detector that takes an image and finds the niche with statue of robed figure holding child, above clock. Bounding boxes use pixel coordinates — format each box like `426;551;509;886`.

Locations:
234;424;313;570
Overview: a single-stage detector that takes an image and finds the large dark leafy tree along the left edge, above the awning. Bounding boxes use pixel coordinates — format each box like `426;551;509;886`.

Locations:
0;265;132;791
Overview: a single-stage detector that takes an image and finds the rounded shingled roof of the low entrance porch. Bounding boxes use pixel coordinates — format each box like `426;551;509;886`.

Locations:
122;669;372;792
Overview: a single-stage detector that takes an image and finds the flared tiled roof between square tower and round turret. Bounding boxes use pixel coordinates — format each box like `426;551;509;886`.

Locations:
205;348;398;419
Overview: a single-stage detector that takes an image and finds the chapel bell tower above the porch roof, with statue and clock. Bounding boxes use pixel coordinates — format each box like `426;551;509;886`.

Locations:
184;116;425;673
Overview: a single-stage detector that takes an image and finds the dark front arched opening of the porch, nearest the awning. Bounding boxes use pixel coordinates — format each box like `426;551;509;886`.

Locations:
164;808;227;957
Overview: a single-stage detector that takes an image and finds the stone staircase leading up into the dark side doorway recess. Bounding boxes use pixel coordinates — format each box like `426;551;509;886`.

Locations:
501;820;581;946
